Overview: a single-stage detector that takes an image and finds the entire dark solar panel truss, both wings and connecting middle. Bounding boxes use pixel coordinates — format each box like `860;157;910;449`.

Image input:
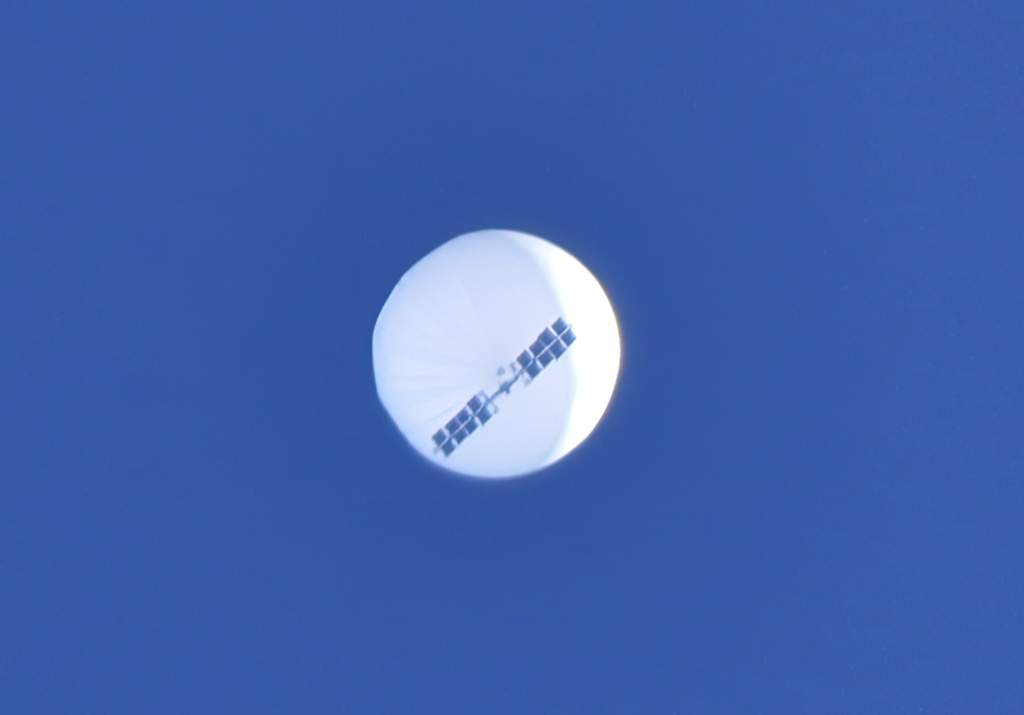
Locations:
432;318;575;457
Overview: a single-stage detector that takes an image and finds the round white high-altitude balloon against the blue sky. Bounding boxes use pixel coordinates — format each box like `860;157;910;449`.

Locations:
373;230;622;477
